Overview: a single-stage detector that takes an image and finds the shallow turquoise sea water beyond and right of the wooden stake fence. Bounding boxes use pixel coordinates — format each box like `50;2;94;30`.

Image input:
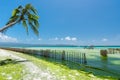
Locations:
2;46;120;76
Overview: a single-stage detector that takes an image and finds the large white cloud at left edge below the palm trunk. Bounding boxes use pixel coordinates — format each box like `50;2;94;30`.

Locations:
0;33;18;42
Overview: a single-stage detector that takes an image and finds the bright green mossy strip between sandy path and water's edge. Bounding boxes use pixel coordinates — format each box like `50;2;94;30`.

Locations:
8;52;117;80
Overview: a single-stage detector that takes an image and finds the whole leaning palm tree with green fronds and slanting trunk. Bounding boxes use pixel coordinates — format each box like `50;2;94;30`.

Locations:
0;4;39;35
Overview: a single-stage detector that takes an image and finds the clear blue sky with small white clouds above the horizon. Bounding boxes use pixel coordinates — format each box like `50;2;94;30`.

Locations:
0;0;120;45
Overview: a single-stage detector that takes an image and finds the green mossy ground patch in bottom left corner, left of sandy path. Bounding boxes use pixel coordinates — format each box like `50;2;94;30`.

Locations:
0;58;24;80
